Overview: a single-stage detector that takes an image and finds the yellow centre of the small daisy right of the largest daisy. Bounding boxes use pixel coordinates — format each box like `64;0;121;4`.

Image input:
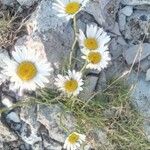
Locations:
64;79;78;92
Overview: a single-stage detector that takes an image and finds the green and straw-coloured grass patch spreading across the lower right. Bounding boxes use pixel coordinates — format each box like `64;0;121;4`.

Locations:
29;80;150;150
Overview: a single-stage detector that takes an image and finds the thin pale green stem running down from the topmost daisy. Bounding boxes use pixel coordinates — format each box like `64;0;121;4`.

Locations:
69;16;77;68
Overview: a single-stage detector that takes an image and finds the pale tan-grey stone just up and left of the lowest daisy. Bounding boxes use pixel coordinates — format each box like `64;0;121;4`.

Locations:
37;105;75;143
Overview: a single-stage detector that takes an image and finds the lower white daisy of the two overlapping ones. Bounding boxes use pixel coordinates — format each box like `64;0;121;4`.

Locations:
82;50;111;71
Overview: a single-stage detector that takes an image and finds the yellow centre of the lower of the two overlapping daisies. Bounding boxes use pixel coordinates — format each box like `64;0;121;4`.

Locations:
87;52;102;64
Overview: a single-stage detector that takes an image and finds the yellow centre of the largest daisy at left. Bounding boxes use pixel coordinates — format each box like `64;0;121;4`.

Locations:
17;61;37;81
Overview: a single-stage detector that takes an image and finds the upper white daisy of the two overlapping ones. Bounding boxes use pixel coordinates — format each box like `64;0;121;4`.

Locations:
78;25;110;51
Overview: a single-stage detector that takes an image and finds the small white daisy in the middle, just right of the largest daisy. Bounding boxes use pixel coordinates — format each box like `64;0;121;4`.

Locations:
55;70;83;96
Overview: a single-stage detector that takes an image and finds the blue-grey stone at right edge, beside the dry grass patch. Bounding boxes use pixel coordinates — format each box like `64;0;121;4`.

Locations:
128;72;150;118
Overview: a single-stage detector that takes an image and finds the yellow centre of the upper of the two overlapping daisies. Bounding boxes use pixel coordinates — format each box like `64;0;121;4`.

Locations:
84;38;98;50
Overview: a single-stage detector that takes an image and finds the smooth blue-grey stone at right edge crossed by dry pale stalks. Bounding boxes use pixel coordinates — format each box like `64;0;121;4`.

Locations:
123;43;150;65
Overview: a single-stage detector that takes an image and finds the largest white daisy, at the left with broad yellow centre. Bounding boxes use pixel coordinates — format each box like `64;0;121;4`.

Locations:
2;46;53;95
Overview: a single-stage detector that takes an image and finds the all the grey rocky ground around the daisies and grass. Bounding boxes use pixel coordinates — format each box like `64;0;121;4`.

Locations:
0;0;150;150
